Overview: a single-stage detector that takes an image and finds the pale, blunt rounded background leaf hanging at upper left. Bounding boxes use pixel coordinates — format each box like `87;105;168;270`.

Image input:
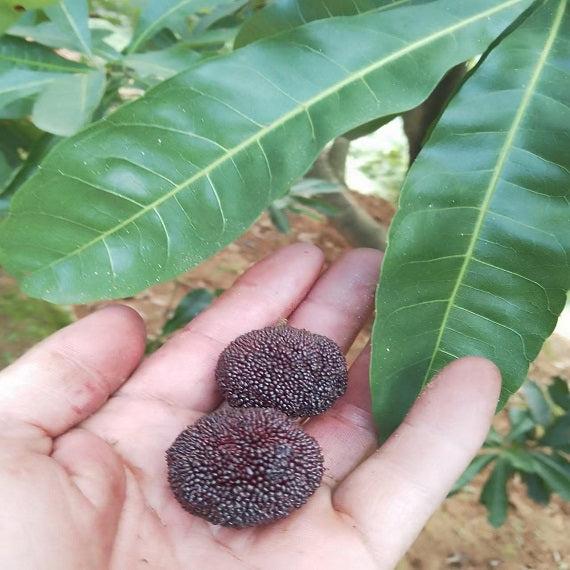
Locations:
32;71;105;136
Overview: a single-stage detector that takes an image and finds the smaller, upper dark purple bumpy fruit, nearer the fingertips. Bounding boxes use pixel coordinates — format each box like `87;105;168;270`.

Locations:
216;325;348;417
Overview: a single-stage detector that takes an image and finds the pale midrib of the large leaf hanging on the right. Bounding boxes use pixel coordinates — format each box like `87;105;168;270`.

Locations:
421;0;568;389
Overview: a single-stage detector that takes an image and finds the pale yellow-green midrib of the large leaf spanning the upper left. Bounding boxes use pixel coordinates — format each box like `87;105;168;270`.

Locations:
31;0;524;277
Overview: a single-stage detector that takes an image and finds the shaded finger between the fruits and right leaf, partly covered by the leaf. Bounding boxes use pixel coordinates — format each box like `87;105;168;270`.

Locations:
303;345;378;488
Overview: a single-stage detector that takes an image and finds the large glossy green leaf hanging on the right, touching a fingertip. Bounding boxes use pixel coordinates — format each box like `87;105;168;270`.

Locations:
371;0;570;437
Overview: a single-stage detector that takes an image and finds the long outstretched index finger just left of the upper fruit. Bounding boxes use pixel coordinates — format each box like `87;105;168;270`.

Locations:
121;244;323;412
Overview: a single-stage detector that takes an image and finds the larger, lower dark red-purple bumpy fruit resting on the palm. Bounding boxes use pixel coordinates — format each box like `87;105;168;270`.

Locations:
166;408;324;528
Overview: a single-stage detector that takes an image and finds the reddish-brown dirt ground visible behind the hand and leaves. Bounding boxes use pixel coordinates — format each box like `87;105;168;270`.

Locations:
2;195;570;570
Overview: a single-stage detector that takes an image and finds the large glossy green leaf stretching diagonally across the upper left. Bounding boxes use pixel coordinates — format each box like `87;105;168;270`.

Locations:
0;0;529;302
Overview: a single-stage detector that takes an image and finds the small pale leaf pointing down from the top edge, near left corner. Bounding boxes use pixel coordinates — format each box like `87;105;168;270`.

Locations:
44;0;92;56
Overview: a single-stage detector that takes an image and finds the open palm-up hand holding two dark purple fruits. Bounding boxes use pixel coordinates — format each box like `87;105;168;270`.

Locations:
0;244;500;570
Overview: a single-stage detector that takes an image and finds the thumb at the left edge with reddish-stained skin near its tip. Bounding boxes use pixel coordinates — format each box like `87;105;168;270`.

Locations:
0;306;145;437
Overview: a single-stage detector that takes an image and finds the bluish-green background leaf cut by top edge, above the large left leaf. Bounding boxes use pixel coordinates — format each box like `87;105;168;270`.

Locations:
127;0;224;53
